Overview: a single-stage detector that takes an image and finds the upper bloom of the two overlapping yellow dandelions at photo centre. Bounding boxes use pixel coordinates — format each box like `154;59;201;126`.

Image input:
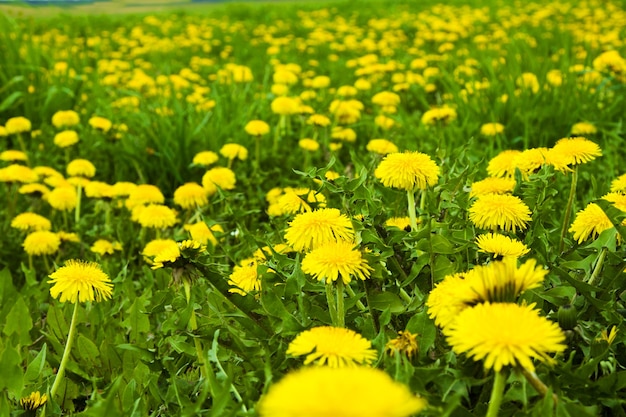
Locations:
285;208;354;252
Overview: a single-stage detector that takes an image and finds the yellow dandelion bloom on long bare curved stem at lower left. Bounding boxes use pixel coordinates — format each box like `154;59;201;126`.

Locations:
48;259;113;304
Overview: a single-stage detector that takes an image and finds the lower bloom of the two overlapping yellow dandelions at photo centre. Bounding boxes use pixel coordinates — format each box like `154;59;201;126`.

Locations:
302;241;373;284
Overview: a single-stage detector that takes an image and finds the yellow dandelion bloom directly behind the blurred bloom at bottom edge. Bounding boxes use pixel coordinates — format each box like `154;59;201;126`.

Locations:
287;326;378;368
